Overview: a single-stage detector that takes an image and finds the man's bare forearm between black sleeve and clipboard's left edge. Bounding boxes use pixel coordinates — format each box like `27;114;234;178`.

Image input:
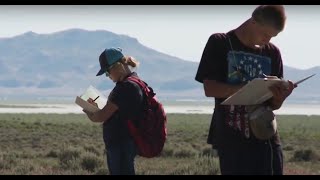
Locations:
203;80;244;98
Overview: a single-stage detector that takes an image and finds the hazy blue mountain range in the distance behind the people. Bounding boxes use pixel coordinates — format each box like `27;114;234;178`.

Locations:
0;29;320;100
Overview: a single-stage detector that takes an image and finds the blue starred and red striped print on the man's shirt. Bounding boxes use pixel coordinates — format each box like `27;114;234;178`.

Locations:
226;51;271;138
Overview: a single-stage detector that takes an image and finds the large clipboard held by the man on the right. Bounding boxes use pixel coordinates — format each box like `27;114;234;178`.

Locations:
221;74;315;105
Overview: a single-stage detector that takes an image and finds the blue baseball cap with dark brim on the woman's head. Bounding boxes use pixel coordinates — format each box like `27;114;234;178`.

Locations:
96;48;124;76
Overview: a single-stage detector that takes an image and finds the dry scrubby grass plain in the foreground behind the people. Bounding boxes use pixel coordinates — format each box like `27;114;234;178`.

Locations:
0;114;320;175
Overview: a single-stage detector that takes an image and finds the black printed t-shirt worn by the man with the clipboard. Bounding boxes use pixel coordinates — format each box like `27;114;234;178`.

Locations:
195;30;283;148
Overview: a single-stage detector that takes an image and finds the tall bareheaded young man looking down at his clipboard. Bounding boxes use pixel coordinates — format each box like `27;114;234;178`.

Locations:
195;5;295;175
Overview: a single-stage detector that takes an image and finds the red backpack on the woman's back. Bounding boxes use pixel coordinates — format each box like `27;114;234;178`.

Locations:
127;76;167;158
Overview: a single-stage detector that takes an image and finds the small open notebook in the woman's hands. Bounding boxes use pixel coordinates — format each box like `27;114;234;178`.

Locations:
75;85;107;112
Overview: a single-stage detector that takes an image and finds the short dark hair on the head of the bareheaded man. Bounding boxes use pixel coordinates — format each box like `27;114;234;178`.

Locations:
252;5;286;31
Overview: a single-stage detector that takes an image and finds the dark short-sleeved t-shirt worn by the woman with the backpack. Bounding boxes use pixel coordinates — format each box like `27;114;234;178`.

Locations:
103;72;143;145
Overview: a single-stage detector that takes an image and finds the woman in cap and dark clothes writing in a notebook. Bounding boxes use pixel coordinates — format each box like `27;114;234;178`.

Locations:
84;48;143;175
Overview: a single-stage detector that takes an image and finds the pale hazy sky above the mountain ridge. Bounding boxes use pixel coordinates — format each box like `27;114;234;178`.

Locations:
0;5;320;69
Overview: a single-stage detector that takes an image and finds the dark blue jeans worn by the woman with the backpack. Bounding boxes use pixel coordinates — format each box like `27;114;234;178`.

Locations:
106;139;137;175
